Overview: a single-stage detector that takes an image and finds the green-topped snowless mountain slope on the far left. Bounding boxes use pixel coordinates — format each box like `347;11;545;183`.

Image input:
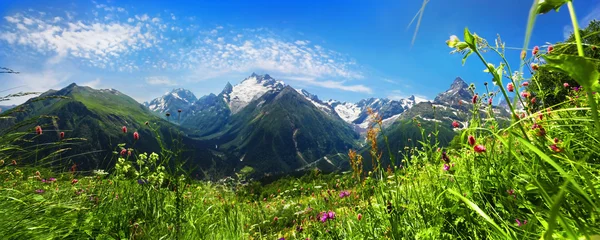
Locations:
0;84;220;173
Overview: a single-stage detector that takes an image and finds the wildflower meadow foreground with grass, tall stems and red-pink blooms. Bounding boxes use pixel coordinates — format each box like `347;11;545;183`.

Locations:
0;0;600;239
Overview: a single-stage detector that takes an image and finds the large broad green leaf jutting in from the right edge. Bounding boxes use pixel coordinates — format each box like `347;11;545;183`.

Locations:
541;54;600;90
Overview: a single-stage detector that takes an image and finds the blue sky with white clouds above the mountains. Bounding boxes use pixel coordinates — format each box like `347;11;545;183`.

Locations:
0;0;600;104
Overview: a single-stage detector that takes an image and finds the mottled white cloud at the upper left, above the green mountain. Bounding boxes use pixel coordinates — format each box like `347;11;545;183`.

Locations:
0;11;160;68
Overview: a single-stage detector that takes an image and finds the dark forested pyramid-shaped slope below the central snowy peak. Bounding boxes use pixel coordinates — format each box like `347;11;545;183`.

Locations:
209;86;358;173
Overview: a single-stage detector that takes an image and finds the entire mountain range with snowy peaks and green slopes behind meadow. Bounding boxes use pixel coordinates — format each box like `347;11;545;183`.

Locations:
0;73;506;176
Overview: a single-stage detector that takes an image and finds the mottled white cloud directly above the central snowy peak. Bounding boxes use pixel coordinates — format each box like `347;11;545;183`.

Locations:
184;29;366;81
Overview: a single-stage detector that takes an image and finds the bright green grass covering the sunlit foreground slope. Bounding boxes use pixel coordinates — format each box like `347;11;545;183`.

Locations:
0;1;600;239
